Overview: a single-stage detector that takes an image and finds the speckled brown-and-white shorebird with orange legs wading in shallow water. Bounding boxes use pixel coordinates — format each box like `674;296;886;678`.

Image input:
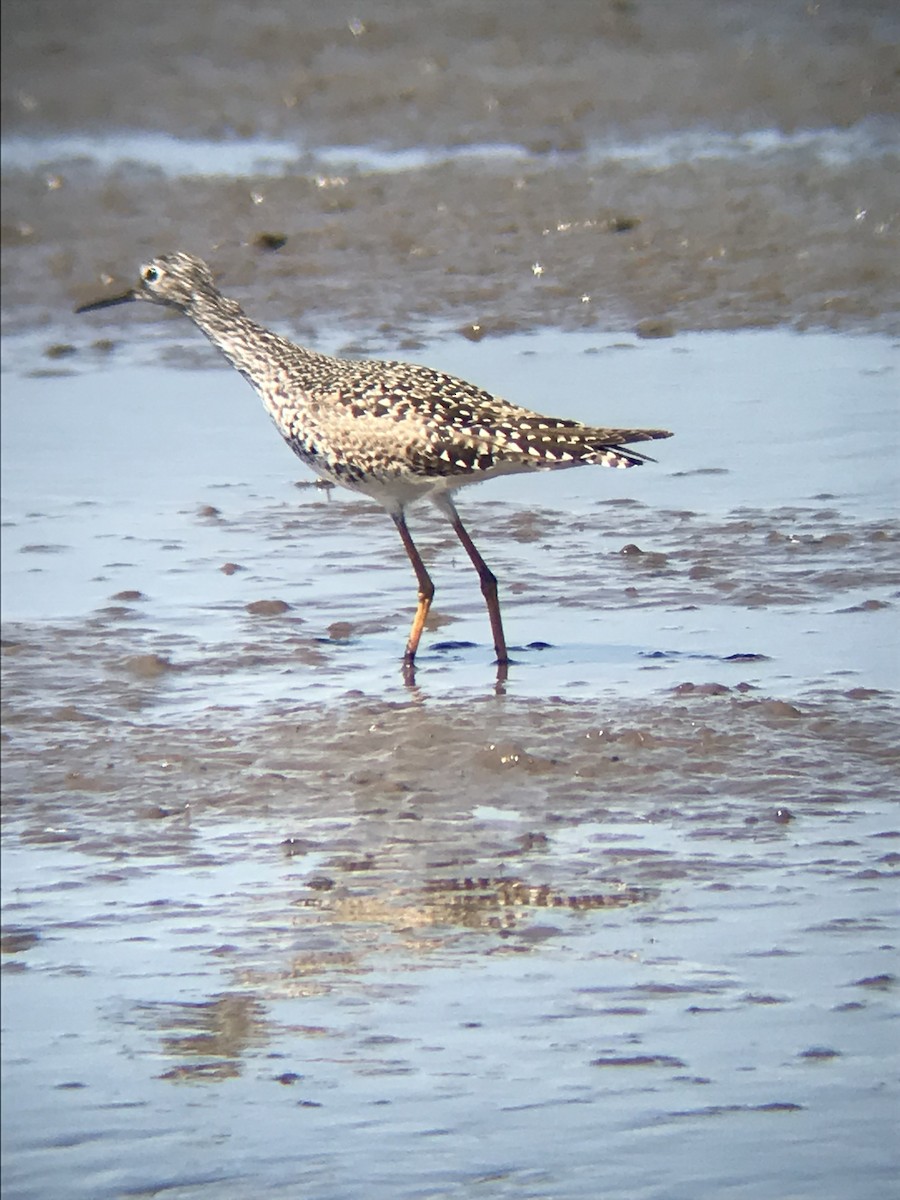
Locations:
76;253;671;673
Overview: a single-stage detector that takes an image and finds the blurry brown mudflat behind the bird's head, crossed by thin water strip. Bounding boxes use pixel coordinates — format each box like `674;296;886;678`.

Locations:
2;0;900;340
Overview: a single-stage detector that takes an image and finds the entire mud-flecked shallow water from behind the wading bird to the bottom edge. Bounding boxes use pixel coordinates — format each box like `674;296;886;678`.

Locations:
4;332;900;1200
